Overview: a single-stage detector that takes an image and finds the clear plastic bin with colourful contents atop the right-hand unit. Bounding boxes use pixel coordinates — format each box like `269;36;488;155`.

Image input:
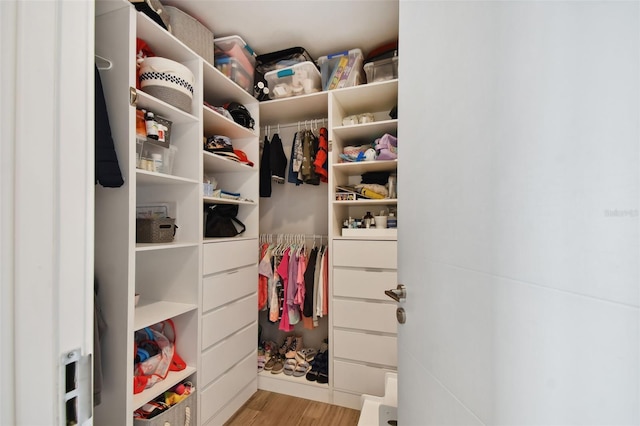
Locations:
318;49;364;90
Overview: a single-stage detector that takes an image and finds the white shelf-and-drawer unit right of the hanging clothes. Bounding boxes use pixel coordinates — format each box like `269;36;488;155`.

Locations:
329;80;398;409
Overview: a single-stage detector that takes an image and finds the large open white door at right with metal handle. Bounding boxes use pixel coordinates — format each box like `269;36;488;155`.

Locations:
398;0;640;426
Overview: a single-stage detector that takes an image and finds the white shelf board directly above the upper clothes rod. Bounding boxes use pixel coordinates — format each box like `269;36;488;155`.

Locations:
260;92;329;127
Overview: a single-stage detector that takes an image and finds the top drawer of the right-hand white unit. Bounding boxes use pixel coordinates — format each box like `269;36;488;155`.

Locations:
333;240;398;270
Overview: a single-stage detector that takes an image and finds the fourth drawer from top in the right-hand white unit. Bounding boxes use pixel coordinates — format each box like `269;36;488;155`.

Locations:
333;330;398;367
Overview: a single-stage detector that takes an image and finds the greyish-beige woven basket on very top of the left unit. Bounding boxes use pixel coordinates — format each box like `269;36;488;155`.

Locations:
164;6;213;65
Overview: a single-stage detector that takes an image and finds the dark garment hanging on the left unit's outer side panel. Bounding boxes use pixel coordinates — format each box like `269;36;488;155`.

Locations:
94;67;124;188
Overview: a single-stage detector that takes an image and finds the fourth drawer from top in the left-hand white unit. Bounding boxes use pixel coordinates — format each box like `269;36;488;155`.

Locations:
202;323;258;386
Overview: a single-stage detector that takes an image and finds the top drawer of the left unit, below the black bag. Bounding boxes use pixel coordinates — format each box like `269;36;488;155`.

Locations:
202;239;258;275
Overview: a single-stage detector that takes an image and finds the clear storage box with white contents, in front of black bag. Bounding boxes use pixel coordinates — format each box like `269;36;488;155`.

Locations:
264;61;322;99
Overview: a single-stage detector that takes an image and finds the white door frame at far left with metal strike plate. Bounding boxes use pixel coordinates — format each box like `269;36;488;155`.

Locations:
0;0;94;425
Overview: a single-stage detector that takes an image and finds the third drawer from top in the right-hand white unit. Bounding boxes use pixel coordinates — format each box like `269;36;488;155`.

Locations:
333;299;398;333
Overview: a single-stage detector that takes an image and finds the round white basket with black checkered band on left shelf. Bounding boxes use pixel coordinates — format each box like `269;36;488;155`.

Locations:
140;56;195;113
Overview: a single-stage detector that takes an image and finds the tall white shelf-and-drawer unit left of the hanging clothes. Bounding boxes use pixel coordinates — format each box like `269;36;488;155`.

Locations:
95;0;259;425
